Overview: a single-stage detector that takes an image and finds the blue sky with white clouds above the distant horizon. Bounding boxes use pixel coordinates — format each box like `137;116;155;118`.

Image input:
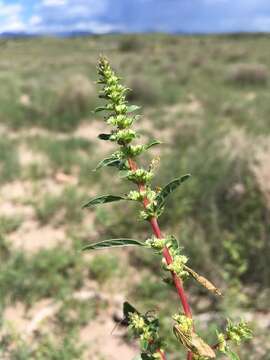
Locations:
0;0;270;33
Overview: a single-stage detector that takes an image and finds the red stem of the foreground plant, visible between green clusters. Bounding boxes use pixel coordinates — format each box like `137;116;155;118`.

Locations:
128;159;192;360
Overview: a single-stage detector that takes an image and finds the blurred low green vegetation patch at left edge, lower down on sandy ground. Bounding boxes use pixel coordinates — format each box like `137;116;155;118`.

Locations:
0;247;83;305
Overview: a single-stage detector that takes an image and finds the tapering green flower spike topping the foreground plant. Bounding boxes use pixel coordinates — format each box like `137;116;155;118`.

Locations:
96;58;160;224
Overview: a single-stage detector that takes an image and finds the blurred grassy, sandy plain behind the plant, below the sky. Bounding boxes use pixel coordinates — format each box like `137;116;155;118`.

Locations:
0;34;270;360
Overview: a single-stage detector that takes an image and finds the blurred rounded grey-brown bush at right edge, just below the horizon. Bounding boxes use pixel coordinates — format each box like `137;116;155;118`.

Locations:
227;64;269;85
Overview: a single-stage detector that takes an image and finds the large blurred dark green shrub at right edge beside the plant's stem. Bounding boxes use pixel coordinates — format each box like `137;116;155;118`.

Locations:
162;134;270;286
